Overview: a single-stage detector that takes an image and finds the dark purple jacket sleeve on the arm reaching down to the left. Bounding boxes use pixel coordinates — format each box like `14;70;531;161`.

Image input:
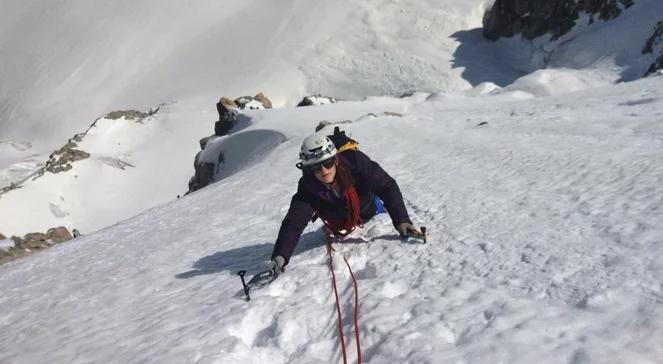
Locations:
272;179;313;265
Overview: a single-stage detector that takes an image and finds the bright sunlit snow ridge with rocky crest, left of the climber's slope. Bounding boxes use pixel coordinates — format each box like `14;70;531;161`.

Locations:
0;101;213;236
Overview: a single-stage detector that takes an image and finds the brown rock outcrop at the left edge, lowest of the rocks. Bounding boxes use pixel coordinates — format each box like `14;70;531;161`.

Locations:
0;226;72;264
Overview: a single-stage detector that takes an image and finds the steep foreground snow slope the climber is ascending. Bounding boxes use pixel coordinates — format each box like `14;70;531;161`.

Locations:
0;76;663;363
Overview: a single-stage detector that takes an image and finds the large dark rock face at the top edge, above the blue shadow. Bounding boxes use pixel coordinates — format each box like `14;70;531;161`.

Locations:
483;0;633;40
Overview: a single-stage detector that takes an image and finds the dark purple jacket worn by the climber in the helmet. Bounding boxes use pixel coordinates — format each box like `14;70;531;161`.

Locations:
272;151;411;264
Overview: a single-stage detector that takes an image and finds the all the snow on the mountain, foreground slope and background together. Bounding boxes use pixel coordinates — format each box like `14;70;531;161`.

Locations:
0;0;663;364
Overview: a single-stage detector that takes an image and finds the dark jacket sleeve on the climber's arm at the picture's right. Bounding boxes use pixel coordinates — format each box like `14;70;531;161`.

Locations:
355;151;412;228
